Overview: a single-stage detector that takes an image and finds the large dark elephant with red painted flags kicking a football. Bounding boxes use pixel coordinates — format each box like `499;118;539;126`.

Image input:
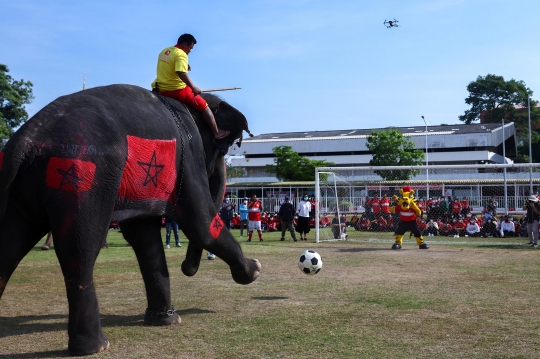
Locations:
0;85;261;355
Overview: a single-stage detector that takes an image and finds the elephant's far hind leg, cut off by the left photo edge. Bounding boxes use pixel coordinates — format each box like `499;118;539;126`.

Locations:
0;205;49;298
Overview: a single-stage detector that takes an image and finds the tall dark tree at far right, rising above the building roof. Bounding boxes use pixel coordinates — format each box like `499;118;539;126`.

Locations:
459;74;540;161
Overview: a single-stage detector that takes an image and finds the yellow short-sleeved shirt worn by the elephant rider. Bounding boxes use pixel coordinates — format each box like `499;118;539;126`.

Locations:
152;46;188;91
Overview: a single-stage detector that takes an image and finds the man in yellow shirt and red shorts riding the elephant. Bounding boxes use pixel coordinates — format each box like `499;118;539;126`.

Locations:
152;34;230;139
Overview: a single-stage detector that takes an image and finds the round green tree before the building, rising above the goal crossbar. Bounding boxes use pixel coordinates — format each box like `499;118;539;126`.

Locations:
366;129;424;181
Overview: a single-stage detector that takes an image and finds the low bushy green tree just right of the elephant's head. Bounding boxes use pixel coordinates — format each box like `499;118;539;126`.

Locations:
265;146;335;181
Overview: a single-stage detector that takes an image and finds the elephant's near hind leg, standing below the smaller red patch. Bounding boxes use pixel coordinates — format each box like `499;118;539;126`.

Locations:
51;205;112;355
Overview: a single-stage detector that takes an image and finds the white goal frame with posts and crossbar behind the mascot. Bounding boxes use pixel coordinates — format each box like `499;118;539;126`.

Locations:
315;163;540;243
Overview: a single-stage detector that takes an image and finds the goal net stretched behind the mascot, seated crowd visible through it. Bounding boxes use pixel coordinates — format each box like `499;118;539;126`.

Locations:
315;163;540;242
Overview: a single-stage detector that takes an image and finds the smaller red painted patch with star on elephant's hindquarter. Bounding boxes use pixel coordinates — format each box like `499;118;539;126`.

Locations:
45;157;96;192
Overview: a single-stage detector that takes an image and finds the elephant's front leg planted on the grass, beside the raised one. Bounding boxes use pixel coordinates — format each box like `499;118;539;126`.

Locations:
120;217;180;325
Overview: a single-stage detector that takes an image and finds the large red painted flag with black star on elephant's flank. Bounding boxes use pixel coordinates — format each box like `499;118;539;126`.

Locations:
118;136;176;200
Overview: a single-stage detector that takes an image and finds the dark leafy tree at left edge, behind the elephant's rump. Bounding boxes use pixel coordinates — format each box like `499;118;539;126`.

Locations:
0;64;34;141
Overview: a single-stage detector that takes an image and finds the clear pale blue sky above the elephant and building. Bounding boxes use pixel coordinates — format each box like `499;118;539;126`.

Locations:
0;0;540;134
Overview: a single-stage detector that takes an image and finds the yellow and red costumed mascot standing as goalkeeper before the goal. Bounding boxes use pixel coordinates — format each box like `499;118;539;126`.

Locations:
390;186;429;249
